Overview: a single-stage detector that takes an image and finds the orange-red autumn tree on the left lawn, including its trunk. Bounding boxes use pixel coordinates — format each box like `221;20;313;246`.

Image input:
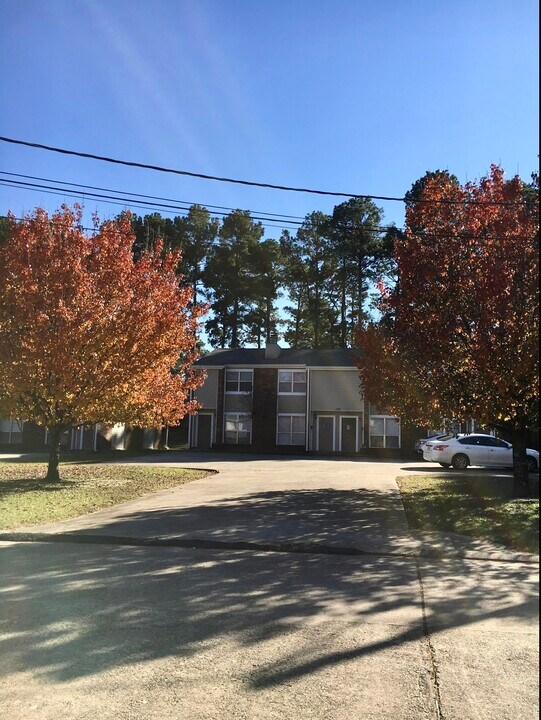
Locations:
0;206;206;481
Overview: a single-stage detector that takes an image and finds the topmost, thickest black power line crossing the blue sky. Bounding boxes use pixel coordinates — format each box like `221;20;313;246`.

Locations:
0;136;526;206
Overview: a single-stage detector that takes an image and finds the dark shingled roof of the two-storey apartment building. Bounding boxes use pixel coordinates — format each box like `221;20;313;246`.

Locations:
195;348;359;368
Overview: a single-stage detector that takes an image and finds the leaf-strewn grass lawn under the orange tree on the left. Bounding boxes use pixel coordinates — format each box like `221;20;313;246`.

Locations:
0;461;208;530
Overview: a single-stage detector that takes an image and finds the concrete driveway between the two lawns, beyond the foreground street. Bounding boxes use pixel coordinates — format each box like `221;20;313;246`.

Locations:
8;452;528;560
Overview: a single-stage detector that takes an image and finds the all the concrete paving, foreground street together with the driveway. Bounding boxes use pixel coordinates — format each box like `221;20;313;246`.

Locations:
0;454;538;720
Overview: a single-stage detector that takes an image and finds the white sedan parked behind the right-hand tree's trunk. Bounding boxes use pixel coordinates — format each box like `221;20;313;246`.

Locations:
423;434;539;472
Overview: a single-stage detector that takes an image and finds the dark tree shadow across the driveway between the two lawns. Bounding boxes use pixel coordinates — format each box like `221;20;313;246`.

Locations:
50;488;408;548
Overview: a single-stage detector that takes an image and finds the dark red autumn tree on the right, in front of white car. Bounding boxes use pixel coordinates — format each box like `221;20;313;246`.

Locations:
359;166;539;494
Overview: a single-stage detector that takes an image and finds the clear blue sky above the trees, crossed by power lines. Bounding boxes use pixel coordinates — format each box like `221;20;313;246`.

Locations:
0;0;539;237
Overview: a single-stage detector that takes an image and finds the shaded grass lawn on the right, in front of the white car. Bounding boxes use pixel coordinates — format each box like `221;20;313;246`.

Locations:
397;475;539;553
